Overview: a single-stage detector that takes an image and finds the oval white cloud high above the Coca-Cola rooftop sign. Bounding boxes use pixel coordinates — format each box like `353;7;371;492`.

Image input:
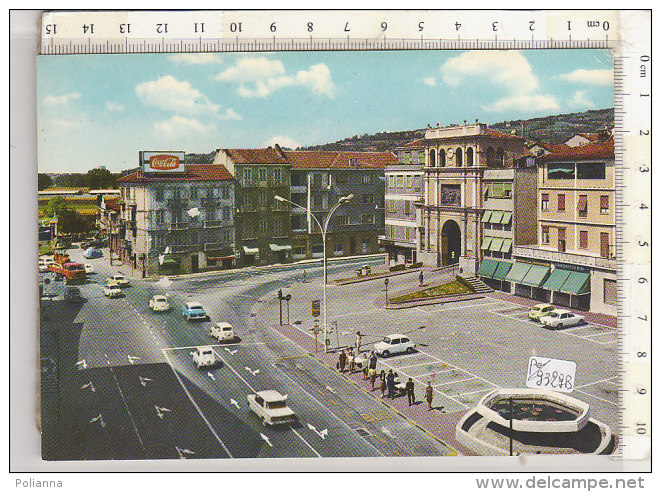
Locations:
135;75;220;115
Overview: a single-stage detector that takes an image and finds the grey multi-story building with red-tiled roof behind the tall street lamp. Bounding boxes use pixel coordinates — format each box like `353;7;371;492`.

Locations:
283;151;396;260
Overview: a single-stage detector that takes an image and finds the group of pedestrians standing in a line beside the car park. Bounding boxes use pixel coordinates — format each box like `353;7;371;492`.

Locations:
337;332;434;410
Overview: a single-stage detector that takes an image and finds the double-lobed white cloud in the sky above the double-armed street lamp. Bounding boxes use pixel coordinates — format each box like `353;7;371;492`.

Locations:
216;57;335;98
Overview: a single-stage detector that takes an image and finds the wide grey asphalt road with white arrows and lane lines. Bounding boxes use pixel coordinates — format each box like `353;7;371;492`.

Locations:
41;249;452;460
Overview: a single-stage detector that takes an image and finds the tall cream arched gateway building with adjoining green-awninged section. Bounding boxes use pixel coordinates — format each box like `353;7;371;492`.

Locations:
417;123;525;275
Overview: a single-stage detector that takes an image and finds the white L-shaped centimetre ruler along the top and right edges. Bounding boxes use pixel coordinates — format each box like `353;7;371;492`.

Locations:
40;10;652;460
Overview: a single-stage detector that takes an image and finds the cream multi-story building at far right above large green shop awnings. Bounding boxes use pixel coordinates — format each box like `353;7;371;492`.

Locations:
509;138;617;315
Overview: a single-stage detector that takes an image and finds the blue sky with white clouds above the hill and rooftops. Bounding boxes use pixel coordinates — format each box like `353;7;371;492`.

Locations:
37;50;613;172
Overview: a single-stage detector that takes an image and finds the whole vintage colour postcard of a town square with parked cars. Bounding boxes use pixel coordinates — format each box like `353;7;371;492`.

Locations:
32;10;648;469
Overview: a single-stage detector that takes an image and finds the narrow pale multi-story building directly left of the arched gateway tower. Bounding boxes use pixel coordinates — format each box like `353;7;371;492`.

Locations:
379;139;425;265
